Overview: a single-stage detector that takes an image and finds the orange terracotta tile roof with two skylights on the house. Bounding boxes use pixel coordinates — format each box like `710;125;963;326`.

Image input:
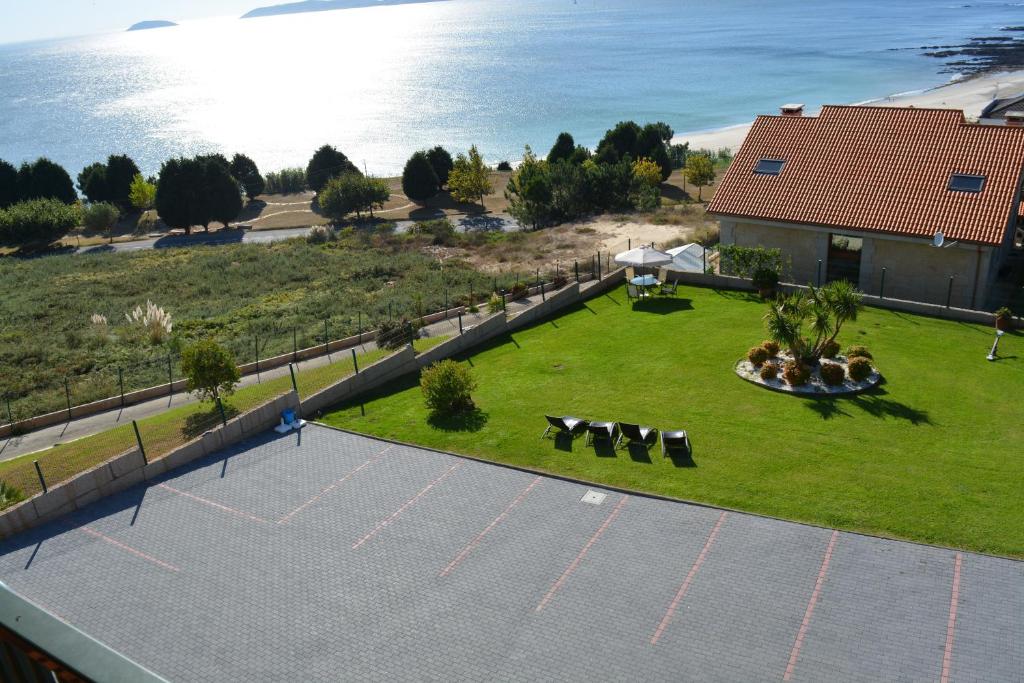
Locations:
708;105;1024;245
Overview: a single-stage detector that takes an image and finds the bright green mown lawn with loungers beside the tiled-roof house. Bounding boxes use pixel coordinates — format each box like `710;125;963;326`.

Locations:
326;288;1024;557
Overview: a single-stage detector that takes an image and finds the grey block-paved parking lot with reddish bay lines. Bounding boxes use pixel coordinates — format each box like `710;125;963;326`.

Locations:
0;425;1024;681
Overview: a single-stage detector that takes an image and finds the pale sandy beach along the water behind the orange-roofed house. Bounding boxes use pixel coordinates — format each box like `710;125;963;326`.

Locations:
673;71;1024;150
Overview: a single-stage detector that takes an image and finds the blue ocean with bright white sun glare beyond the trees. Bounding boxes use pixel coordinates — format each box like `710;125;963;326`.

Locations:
0;0;1024;175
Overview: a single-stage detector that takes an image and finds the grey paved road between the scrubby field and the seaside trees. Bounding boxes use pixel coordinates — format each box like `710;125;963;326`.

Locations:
72;214;519;254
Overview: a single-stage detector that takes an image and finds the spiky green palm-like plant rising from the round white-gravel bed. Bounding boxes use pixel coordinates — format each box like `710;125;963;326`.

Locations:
765;280;862;362
